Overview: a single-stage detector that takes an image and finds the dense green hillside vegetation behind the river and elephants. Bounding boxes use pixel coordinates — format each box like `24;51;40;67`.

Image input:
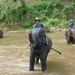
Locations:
0;0;75;30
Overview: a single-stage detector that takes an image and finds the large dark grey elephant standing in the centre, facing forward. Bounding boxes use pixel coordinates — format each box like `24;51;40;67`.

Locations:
29;28;52;71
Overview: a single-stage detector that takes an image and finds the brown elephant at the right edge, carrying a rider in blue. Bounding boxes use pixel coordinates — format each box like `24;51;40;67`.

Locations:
65;28;75;44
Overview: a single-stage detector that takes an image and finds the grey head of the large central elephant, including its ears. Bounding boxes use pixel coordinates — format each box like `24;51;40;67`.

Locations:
29;28;46;48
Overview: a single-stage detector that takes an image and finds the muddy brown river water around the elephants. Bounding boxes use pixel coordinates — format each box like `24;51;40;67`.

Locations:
0;31;75;75
